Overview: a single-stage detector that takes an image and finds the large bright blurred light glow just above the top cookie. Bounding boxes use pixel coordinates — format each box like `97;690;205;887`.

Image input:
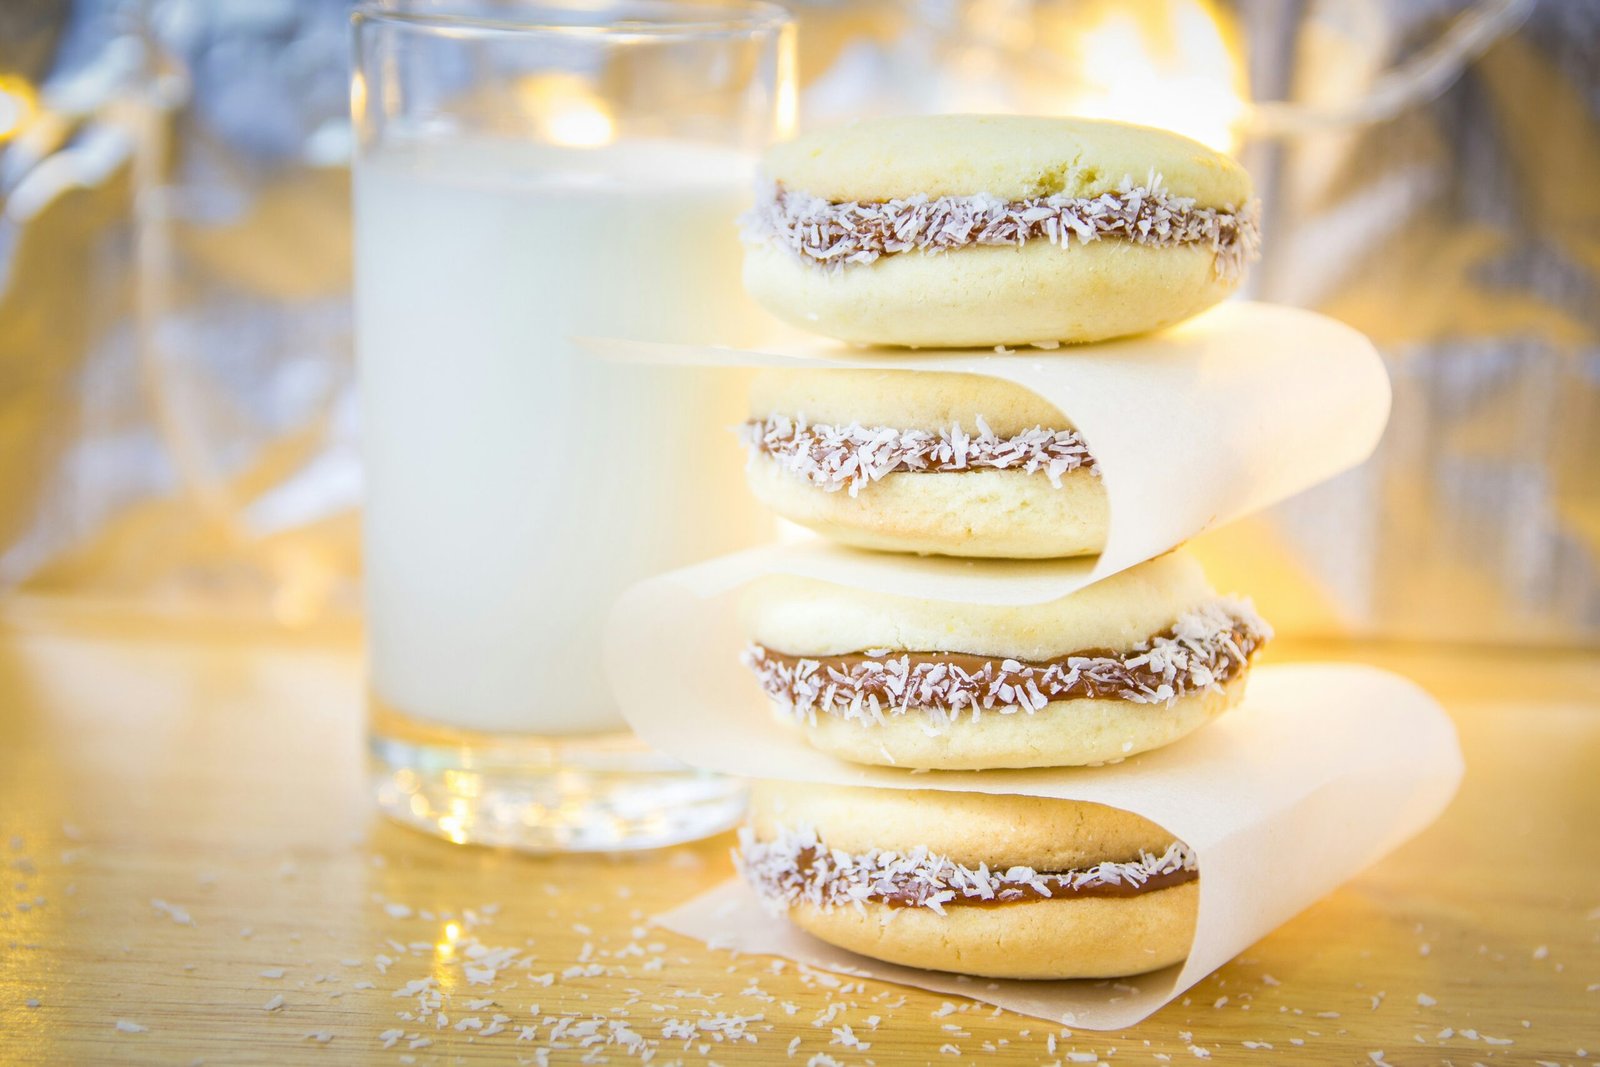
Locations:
1059;0;1248;152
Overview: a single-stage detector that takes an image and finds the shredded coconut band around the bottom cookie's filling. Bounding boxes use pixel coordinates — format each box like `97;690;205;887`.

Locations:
733;827;1197;915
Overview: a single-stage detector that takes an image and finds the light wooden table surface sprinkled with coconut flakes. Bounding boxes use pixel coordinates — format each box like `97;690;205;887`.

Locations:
0;601;1600;1065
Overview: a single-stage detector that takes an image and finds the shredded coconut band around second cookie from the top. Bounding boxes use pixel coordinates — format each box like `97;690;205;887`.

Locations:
738;414;1099;496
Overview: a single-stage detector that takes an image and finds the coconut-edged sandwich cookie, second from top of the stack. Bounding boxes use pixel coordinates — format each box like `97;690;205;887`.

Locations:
741;370;1110;558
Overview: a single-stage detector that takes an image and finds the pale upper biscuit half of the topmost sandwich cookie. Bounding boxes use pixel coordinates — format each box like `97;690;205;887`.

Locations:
763;115;1251;208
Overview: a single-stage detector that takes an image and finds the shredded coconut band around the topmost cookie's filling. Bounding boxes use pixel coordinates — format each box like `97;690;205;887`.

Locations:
742;173;1261;282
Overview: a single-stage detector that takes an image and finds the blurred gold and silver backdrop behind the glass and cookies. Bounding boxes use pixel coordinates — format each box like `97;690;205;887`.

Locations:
0;0;1600;646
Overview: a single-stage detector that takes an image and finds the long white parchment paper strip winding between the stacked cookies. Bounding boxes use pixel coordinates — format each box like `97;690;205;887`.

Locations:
587;302;1433;1029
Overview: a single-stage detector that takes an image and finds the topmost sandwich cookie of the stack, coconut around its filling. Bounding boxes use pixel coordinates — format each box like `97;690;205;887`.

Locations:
744;115;1261;347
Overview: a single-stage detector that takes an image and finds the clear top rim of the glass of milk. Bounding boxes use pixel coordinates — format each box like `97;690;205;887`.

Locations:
350;0;794;40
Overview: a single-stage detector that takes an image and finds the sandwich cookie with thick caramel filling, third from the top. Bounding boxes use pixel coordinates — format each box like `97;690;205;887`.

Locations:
744;553;1272;769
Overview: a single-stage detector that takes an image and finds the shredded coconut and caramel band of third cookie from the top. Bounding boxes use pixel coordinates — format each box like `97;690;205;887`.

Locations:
741;597;1272;723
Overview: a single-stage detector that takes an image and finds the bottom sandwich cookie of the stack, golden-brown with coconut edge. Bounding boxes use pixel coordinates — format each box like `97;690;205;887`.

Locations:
734;782;1200;979
